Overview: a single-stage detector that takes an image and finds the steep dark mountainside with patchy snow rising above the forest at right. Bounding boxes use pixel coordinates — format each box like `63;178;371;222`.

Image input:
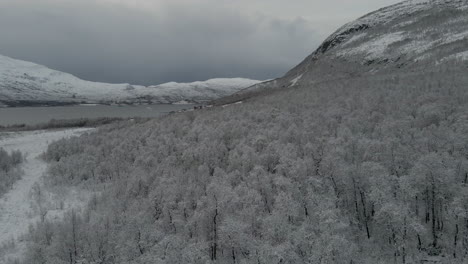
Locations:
219;0;468;102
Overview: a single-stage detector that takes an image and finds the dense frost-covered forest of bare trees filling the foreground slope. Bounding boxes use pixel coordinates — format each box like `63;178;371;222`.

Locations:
11;62;468;264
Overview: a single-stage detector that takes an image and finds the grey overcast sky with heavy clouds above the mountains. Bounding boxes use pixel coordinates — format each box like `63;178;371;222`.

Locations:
0;0;399;85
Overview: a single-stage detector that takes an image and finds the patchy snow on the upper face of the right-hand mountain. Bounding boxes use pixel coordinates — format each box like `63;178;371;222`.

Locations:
324;0;468;63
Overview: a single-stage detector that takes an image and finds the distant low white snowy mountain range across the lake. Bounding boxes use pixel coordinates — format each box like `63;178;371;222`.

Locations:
0;55;258;105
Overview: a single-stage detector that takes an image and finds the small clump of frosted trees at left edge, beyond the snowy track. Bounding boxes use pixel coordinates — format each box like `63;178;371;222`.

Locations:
0;148;24;198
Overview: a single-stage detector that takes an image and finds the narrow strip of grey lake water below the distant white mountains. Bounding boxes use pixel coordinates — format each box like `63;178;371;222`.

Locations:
0;104;193;126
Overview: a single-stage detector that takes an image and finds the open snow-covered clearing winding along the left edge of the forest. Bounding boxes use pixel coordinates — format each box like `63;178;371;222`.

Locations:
0;128;89;263
